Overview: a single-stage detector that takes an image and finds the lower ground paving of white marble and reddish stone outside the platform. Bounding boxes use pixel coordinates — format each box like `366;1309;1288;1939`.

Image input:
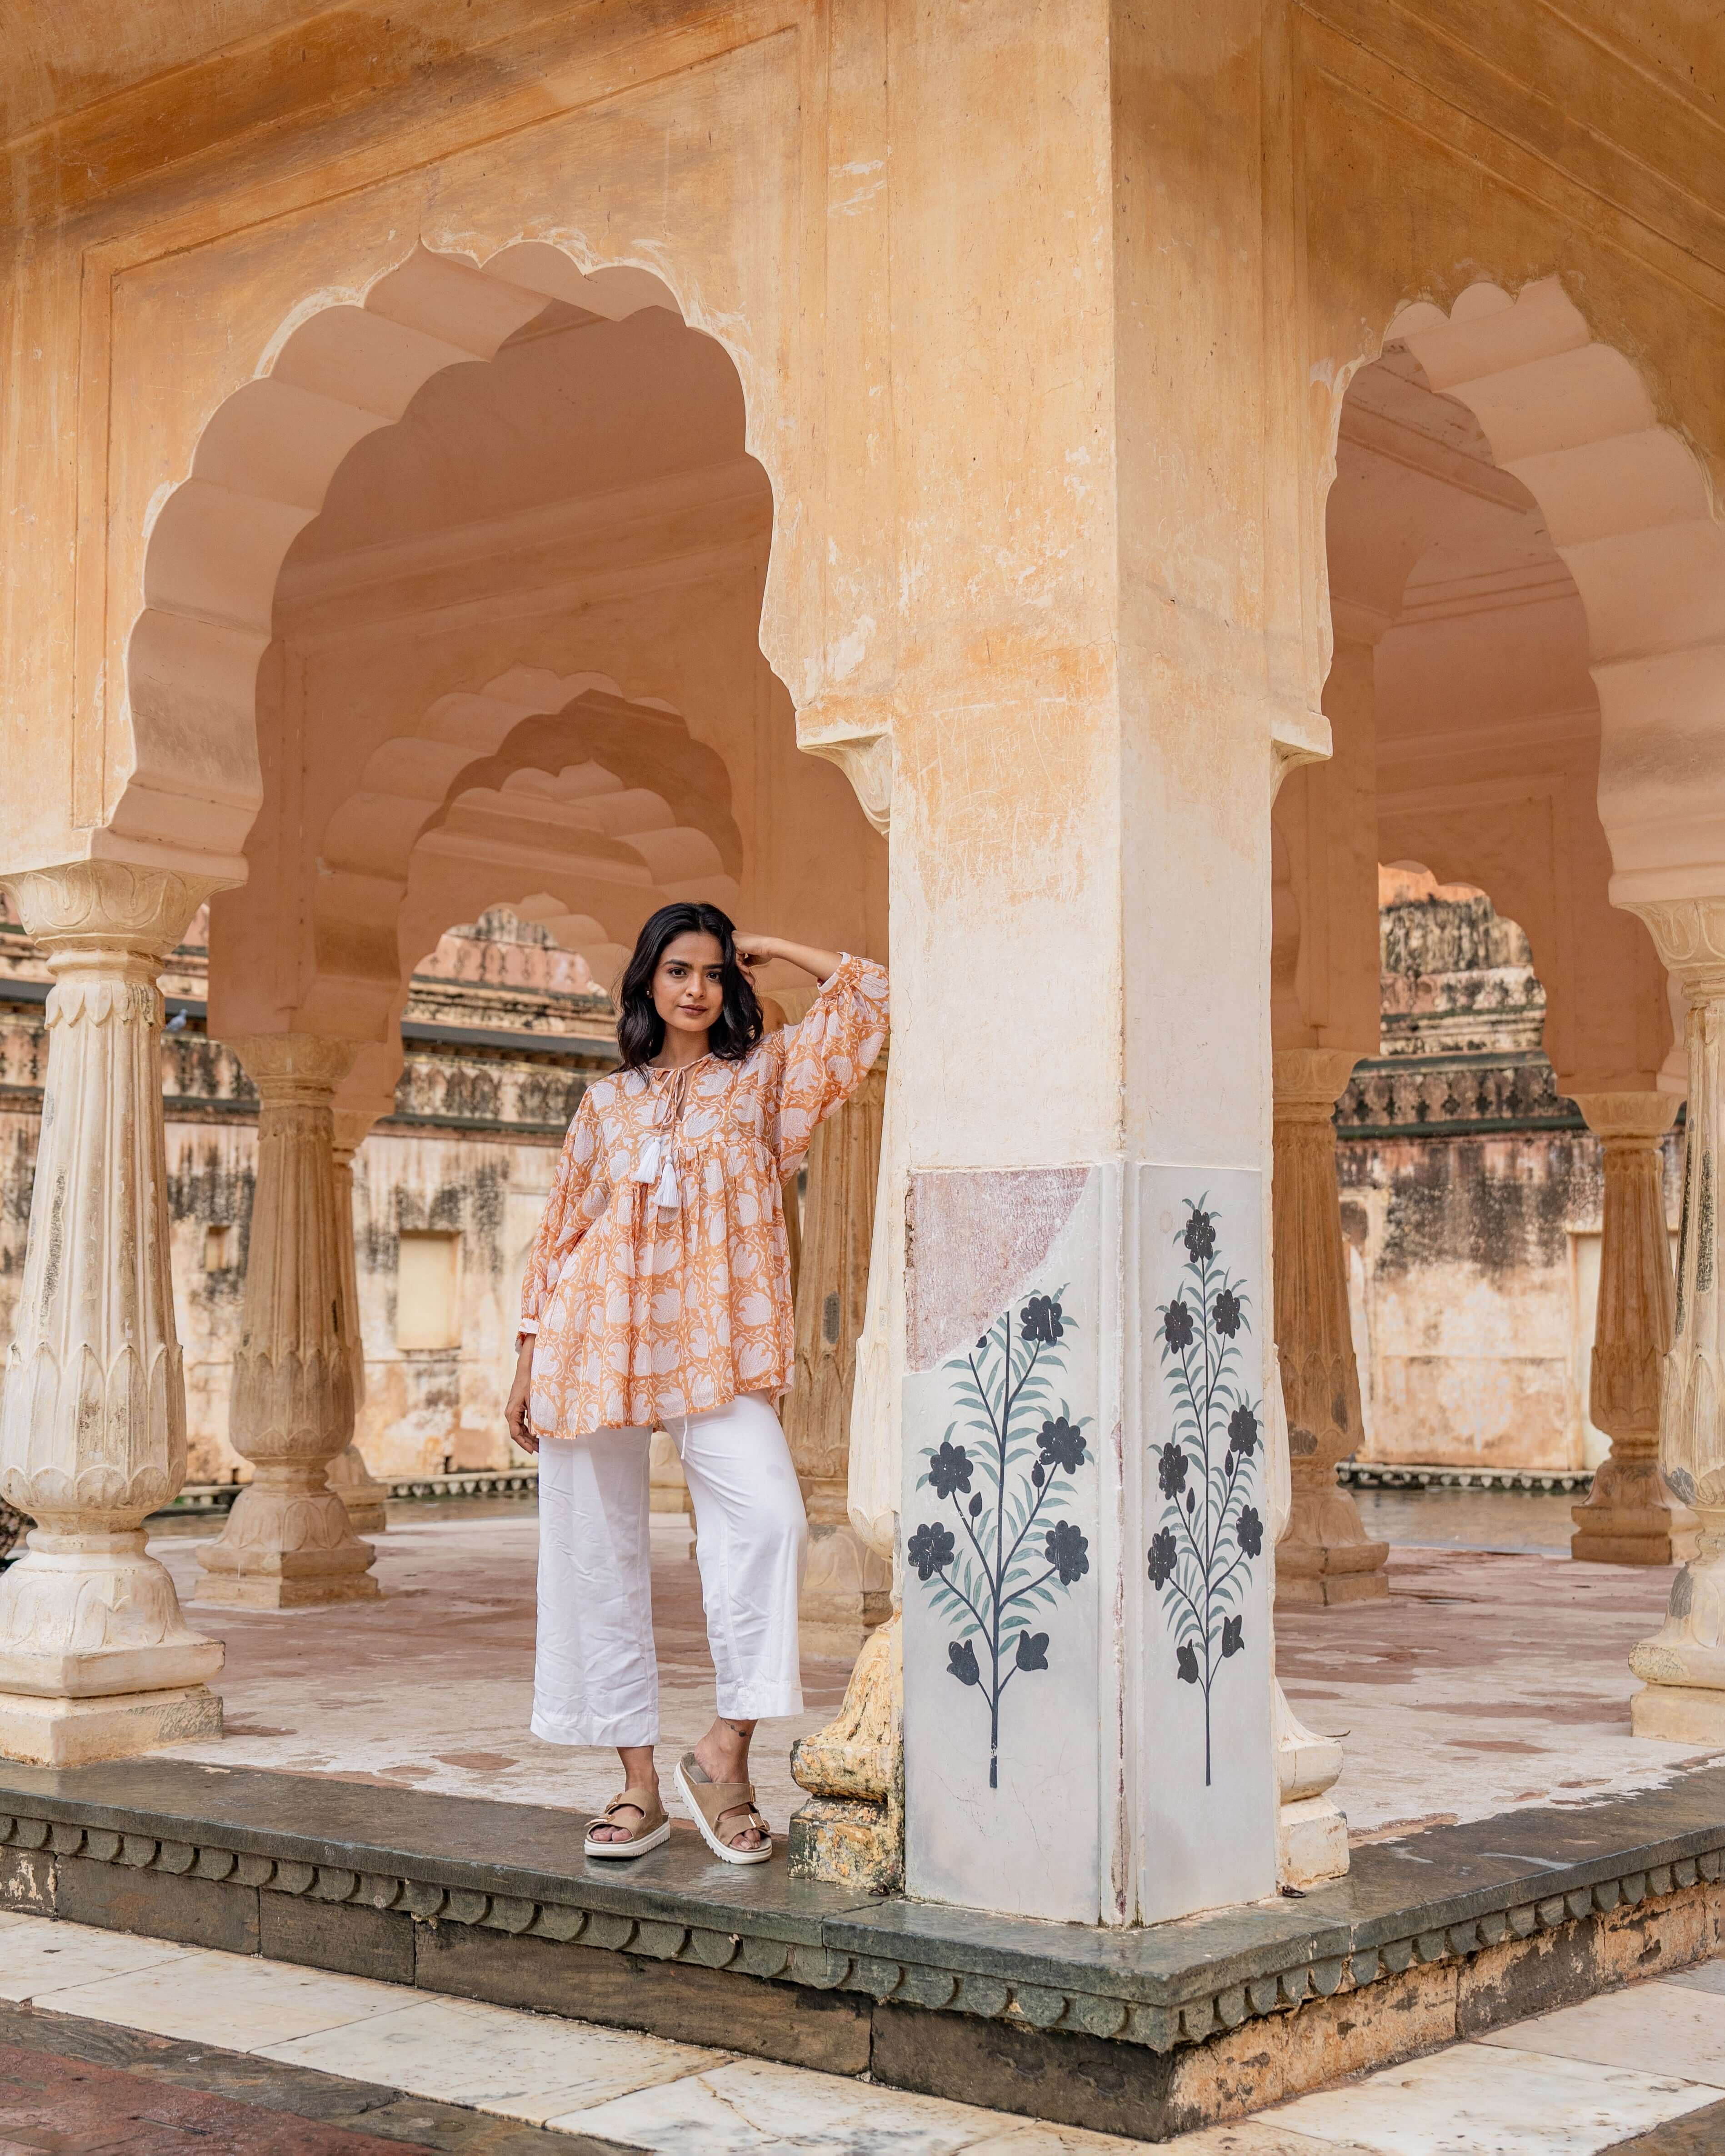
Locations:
0;1915;1725;2156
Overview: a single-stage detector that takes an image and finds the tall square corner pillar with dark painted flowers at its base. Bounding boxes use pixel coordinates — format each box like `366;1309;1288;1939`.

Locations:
884;4;1302;1923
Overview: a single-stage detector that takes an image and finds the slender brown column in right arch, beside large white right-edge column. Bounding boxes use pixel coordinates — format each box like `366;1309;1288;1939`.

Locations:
1570;1093;1695;1565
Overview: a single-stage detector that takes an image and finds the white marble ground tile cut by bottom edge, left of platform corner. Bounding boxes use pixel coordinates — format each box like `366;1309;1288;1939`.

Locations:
560;2059;1030;2156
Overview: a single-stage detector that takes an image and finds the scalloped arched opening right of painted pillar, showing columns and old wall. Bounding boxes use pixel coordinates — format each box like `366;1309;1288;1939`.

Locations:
1272;282;1725;1871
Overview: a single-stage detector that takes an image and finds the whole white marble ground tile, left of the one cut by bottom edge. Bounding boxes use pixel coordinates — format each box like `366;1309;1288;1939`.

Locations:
252;1992;725;2124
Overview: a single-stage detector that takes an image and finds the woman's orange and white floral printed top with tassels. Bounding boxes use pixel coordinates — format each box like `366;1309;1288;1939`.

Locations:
522;957;886;1438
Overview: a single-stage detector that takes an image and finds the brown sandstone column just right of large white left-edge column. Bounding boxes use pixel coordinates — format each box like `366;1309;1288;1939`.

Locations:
196;1033;377;1611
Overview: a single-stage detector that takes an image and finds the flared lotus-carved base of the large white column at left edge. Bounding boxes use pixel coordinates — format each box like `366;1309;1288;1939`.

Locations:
0;1526;226;1716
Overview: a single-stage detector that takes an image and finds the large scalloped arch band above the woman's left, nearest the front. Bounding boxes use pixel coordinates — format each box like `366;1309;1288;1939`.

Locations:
110;241;746;860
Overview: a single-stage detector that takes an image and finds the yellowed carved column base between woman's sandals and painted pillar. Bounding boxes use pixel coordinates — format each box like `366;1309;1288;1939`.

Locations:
789;1615;904;1893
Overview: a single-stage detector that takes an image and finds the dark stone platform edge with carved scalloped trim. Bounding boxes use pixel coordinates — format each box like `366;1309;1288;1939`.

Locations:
0;1757;1725;2141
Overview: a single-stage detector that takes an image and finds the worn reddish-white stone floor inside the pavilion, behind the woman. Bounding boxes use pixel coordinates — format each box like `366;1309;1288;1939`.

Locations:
153;1492;1695;1837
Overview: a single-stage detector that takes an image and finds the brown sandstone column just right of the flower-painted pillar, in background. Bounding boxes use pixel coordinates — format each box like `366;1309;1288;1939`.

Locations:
1270;1048;1389;1608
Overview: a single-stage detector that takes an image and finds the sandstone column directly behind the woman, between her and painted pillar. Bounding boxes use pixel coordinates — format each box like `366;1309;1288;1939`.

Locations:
785;1056;893;1660
